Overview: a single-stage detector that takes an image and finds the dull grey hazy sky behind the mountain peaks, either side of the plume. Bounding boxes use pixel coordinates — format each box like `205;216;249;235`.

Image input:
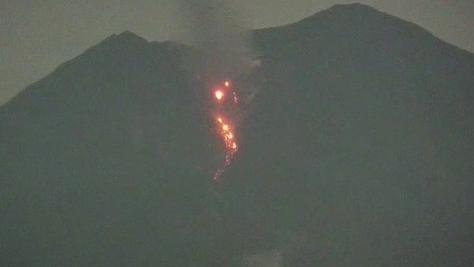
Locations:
0;0;474;104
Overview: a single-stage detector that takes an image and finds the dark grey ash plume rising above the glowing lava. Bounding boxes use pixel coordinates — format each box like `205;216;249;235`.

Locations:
176;0;253;81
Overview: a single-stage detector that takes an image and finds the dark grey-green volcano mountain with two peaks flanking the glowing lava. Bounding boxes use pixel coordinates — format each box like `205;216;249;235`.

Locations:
0;4;474;266
